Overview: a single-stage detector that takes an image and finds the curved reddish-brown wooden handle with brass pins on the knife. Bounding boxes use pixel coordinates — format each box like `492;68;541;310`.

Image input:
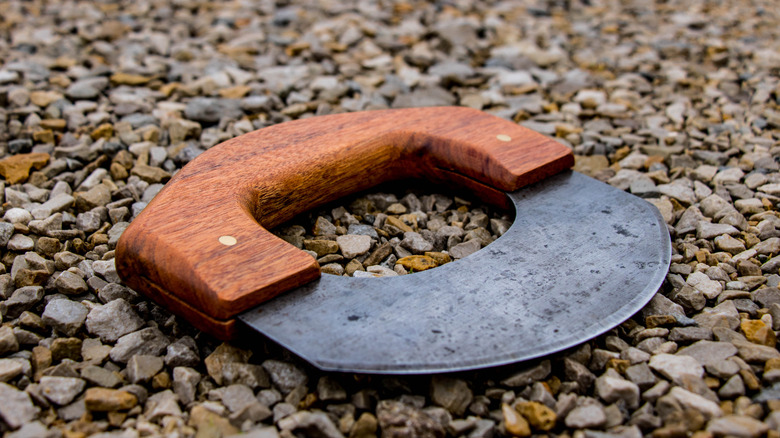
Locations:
116;107;574;326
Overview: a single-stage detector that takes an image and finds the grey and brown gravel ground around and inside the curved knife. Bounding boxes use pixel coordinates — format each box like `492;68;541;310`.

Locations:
0;0;780;438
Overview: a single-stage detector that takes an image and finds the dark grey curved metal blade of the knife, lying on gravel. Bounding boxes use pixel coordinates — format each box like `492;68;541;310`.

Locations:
239;171;671;374
